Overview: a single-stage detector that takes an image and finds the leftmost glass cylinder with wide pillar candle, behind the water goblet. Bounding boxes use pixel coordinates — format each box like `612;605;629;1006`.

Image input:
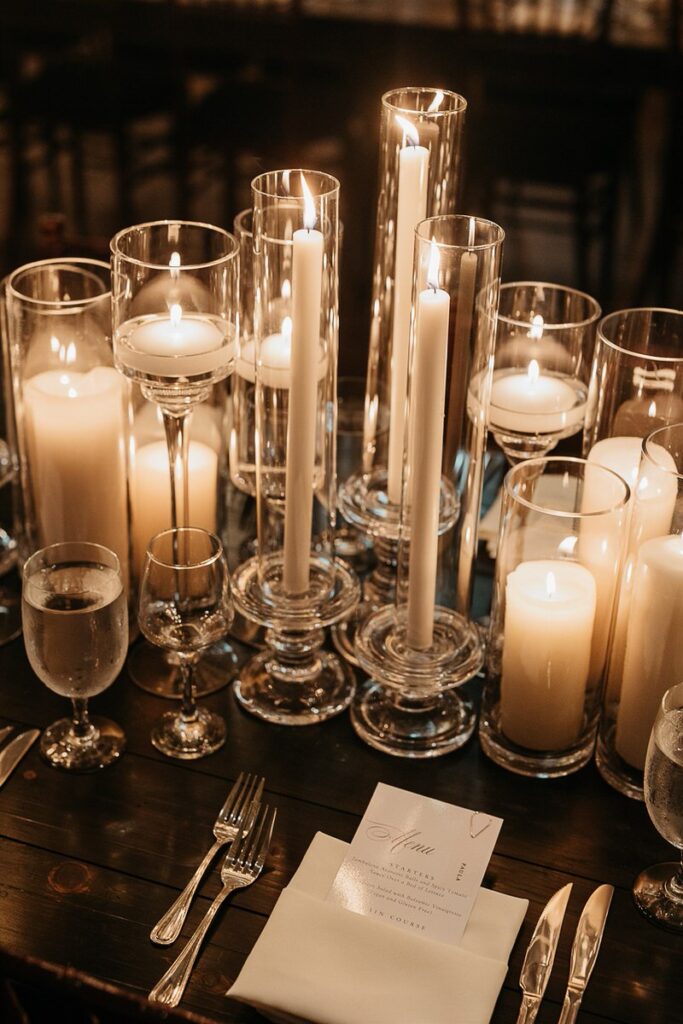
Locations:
5;259;130;589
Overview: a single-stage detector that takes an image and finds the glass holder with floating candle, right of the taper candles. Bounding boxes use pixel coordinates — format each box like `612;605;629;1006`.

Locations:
488;282;600;463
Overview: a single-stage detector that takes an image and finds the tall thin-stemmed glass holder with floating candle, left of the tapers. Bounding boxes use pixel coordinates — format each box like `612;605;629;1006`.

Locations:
111;221;239;696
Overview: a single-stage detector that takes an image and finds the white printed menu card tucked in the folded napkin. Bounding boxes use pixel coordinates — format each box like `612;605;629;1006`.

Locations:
327;782;503;946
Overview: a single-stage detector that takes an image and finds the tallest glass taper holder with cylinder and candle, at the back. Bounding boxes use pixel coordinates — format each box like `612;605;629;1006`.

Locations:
334;88;467;662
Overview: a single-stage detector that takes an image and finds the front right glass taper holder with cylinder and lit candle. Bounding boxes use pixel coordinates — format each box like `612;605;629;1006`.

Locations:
351;216;503;758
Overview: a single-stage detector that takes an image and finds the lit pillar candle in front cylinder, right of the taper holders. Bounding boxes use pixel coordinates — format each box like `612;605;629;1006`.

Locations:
501;559;596;751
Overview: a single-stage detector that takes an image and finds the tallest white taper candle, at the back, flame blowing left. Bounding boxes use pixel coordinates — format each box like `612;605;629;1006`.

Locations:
387;117;429;505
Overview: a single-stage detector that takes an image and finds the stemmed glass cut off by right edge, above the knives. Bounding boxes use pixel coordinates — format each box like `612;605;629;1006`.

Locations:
633;683;683;931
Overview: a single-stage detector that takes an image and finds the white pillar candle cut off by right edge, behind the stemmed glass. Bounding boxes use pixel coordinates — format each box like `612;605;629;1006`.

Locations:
614;535;683;770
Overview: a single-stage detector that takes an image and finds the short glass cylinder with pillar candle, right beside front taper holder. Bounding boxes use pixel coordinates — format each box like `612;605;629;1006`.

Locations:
479;456;631;778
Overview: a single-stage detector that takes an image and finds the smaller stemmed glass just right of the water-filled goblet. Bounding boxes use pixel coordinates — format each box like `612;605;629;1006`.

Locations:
138;527;233;760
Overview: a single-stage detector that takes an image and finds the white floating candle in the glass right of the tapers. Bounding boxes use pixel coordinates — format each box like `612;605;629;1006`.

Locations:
489;359;586;434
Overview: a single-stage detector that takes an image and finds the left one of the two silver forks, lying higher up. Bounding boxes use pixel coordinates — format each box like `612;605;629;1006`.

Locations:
150;772;265;946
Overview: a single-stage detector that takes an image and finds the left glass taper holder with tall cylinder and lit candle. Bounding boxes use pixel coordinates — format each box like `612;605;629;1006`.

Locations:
233;170;359;725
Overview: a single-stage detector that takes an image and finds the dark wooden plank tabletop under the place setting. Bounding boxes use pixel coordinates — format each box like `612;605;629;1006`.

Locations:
0;536;683;1024
